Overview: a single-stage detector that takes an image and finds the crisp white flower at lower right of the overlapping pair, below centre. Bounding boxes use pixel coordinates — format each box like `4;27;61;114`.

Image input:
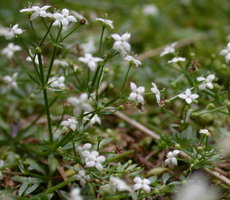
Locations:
85;151;105;171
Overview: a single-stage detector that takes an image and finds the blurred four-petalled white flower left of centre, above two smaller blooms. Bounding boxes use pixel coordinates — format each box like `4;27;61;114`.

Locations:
67;93;92;116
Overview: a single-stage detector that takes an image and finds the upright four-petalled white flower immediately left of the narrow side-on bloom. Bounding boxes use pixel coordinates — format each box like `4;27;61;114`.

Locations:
128;82;145;104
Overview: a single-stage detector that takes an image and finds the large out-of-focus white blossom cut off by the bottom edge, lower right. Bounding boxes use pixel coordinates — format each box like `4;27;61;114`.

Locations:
174;173;220;200
